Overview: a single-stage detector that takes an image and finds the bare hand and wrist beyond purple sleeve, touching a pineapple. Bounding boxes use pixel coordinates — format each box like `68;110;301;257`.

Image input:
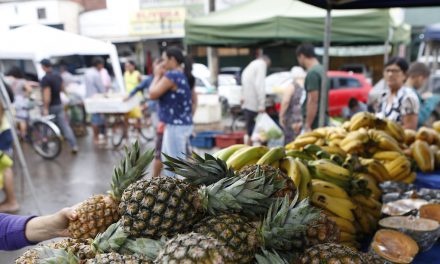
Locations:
25;207;78;242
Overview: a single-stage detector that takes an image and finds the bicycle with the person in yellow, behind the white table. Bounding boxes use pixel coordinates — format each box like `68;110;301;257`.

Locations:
107;99;156;148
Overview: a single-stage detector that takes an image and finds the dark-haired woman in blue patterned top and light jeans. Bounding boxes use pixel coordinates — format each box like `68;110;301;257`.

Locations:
149;47;195;176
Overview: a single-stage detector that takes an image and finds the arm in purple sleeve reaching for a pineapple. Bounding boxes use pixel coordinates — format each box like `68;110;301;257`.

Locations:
0;208;77;250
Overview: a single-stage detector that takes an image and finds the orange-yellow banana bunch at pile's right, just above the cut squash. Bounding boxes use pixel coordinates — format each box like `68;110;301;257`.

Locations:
373;151;416;183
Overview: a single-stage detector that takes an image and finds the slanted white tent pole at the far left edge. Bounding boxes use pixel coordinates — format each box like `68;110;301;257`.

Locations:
0;76;42;215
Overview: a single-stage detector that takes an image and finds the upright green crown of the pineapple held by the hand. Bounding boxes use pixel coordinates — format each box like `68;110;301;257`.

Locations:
110;141;154;201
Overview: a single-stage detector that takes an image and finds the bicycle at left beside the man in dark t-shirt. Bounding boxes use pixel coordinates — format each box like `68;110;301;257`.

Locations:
25;100;62;160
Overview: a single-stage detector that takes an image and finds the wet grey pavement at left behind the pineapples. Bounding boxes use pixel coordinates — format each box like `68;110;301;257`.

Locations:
0;131;152;264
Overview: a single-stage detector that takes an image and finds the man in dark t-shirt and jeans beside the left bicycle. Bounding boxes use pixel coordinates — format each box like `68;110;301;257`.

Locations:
40;59;78;154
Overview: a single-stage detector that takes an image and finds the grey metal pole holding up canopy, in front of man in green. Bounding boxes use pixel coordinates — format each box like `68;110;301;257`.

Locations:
318;7;332;127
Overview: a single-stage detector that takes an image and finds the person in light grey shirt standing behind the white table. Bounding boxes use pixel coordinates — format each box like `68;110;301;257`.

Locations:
84;57;105;145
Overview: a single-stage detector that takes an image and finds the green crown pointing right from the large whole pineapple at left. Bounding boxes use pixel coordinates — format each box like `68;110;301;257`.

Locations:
199;175;278;216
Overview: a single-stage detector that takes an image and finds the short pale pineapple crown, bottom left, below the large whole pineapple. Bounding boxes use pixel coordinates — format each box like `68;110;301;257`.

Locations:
92;222;128;253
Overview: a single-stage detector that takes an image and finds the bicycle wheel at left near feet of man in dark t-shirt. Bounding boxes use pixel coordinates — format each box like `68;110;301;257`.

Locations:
30;121;61;159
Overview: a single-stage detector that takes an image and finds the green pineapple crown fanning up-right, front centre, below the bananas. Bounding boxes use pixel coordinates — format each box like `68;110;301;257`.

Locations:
260;196;322;250
